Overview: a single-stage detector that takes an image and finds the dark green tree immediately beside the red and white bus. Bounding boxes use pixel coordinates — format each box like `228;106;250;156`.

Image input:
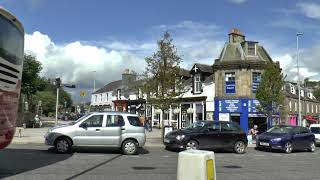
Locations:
21;54;42;111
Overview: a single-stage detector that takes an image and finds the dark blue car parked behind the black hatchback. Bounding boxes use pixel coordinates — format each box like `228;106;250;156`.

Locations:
256;125;316;153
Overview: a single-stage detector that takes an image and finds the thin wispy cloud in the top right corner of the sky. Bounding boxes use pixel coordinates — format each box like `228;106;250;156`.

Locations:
297;2;320;19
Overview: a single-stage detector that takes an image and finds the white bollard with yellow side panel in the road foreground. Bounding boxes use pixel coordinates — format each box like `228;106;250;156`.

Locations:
177;150;216;180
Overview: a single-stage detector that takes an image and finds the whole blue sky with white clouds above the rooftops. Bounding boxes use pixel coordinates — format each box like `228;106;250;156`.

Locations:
0;0;320;101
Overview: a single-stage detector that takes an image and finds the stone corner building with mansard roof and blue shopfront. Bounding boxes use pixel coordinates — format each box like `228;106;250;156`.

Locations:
213;29;279;132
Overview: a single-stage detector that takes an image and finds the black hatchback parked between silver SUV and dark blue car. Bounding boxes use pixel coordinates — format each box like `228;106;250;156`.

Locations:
164;121;248;153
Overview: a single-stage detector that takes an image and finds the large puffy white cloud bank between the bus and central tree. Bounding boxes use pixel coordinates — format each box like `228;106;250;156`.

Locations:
25;32;144;101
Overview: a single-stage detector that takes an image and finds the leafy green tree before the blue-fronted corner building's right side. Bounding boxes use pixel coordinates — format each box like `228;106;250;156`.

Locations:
256;62;284;125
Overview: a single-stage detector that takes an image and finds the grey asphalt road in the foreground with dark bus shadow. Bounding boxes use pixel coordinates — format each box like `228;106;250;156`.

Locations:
0;145;320;180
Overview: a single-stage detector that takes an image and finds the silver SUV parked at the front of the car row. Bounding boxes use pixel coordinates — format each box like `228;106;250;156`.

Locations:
45;112;146;155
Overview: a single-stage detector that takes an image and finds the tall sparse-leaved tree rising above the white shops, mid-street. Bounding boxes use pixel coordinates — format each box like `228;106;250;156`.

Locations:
142;31;183;136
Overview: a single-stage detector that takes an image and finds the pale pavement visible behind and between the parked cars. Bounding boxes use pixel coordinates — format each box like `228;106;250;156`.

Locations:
11;120;255;147
